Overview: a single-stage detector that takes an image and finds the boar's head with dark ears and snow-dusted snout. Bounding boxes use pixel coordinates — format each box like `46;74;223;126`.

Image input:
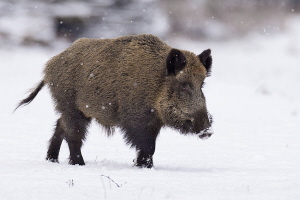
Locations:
157;49;212;139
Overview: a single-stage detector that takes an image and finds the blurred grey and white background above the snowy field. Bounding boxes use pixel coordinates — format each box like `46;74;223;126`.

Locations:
0;0;300;48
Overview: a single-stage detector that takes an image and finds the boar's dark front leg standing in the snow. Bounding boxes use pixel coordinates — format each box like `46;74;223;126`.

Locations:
124;123;160;168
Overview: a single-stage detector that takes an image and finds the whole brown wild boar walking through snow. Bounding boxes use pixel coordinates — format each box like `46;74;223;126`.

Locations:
19;35;212;168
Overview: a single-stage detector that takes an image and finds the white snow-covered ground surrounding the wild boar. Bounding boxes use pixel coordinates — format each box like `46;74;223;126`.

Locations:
0;17;300;200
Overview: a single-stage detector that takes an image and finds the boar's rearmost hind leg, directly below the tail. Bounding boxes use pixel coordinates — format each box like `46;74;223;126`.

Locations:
46;119;65;162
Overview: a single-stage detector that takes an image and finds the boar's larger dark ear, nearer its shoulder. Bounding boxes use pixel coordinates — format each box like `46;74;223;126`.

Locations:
167;49;186;76
